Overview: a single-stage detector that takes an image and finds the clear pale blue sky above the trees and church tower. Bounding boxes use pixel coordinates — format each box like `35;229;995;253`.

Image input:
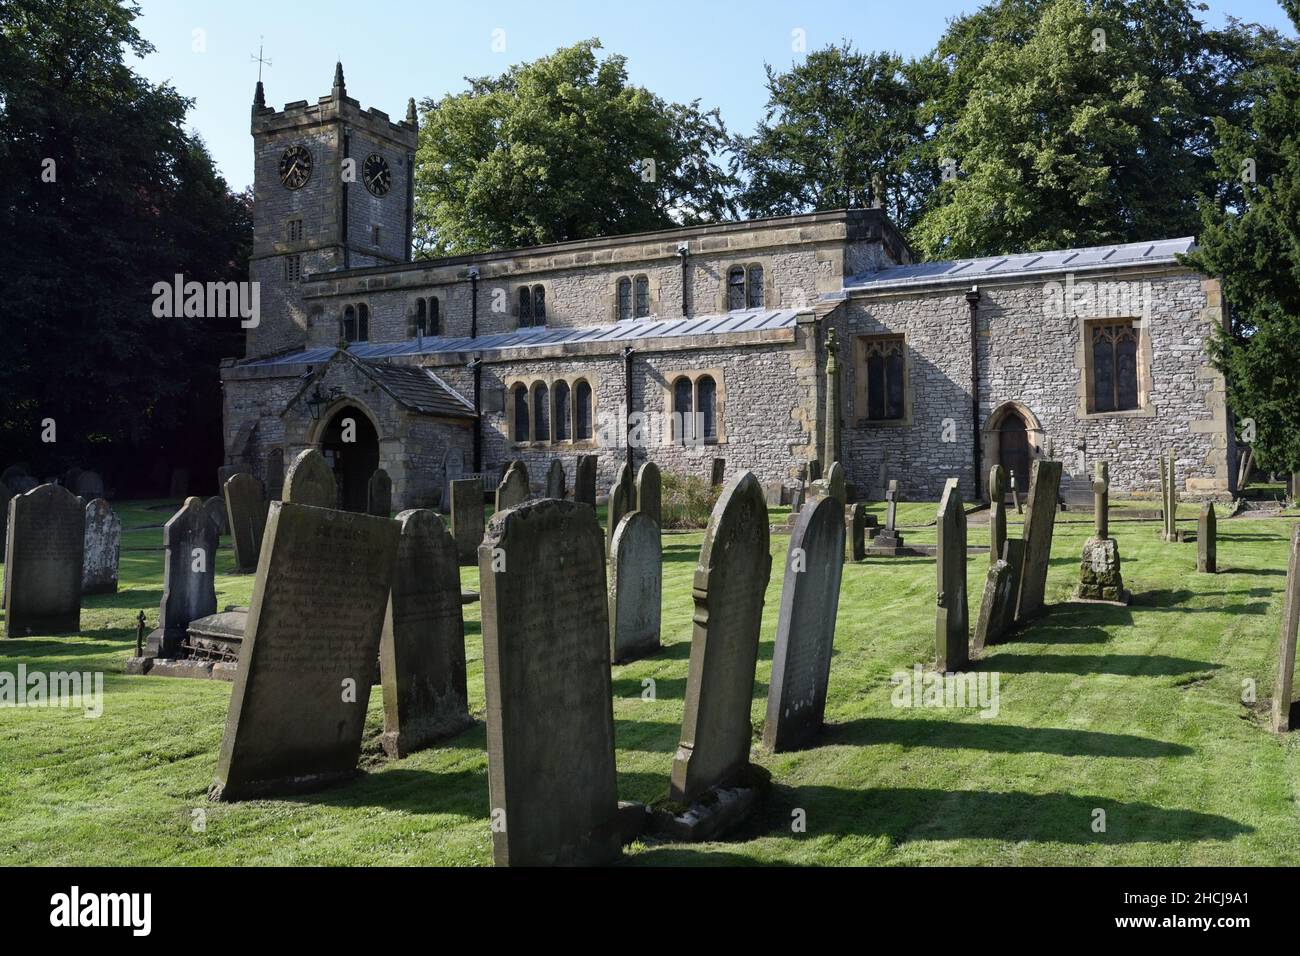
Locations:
133;0;1290;189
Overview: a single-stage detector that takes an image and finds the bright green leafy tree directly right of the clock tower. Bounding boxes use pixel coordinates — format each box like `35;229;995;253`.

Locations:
416;40;736;256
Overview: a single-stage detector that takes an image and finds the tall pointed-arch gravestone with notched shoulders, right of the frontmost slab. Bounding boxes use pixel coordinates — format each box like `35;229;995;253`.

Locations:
670;471;772;803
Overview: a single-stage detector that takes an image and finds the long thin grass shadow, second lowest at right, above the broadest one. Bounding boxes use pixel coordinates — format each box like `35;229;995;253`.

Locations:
819;717;1195;758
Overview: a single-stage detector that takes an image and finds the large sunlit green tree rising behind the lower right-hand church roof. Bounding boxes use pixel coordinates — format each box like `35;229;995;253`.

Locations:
911;0;1261;258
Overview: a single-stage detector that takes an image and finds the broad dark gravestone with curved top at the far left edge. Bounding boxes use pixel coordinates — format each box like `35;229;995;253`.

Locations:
4;485;86;637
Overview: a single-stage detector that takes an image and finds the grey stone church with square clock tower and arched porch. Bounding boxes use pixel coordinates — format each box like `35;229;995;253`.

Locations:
221;68;1235;509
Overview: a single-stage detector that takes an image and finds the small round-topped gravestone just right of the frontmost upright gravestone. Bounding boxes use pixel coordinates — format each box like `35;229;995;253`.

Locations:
610;511;663;663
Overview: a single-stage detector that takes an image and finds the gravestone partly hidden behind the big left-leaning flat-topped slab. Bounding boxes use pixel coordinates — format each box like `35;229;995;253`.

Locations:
380;510;481;758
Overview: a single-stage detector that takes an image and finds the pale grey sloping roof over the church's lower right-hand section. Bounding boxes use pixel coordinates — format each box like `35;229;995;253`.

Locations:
827;237;1196;291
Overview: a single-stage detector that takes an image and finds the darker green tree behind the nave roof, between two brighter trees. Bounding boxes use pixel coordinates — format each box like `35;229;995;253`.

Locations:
737;43;939;230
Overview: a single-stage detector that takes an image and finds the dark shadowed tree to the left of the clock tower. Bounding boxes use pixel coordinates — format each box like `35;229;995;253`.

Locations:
0;0;252;490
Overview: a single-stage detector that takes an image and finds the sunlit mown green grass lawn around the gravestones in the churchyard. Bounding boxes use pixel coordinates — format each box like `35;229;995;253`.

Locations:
0;502;1300;865
